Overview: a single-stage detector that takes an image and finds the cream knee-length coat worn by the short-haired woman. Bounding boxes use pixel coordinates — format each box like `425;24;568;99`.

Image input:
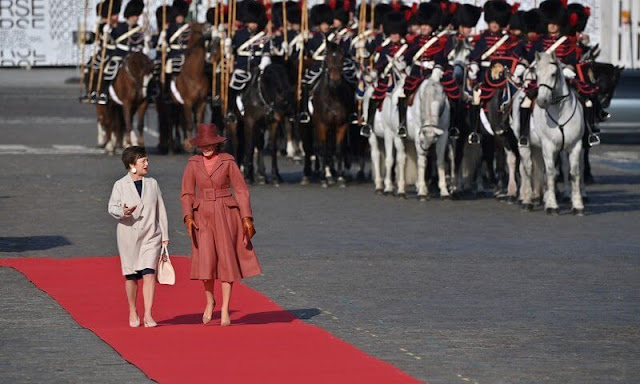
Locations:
109;173;169;275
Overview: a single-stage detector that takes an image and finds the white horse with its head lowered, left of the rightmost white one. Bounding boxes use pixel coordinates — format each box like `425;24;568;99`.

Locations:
396;69;456;200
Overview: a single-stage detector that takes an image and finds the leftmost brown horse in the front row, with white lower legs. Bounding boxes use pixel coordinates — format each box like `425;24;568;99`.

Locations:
107;52;153;147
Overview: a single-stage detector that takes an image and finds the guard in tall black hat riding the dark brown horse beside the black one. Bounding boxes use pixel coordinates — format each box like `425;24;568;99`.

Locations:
300;4;335;123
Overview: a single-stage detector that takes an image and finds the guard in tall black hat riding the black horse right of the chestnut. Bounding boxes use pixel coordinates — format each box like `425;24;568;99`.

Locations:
225;0;271;123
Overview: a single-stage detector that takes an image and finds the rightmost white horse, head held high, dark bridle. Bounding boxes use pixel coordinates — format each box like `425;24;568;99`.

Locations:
523;53;584;215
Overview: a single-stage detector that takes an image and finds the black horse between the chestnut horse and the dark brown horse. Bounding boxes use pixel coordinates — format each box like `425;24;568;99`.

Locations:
242;64;294;186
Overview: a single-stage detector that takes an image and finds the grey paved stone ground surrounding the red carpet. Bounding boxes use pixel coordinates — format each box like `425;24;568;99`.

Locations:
0;71;640;383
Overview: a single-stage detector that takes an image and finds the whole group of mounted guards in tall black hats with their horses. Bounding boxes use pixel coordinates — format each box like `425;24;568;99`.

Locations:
76;0;621;214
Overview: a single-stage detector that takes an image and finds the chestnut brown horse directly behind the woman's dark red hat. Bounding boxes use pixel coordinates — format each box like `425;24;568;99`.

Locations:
171;23;211;152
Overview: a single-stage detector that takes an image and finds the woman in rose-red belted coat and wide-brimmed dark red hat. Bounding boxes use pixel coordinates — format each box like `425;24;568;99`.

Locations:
180;124;261;326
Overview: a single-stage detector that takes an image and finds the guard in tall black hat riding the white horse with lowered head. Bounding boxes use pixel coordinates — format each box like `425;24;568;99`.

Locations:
398;2;447;137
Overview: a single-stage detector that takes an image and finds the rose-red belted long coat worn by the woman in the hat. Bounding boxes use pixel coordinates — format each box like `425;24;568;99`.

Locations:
180;153;262;282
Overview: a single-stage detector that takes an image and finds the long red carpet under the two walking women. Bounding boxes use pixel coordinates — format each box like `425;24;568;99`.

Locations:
0;257;418;383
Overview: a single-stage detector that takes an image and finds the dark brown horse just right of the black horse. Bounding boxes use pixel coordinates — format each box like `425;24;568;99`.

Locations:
305;42;353;188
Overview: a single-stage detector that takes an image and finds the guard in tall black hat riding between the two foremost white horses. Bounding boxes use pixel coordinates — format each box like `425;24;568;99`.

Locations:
468;0;528;144
